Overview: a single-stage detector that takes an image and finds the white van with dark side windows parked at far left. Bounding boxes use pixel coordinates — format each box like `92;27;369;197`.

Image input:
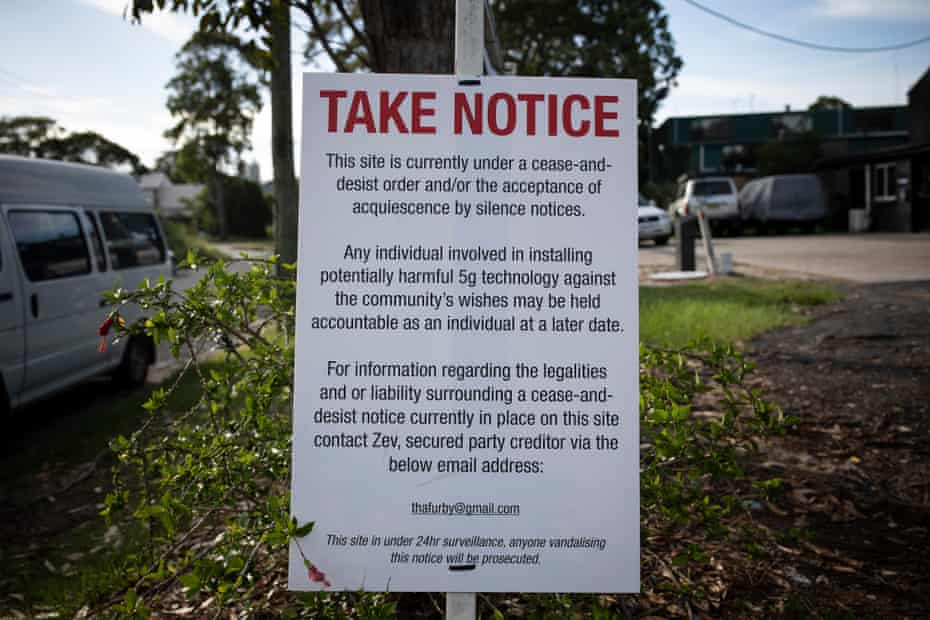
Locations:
0;155;171;412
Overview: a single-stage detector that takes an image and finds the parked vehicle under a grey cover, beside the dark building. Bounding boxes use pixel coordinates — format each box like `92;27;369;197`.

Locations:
739;174;827;229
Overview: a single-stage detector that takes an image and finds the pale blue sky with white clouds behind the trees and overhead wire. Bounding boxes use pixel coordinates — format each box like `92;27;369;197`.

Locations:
0;0;930;180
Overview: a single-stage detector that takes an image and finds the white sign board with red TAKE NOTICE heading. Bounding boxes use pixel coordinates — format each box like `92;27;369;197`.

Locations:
290;74;639;592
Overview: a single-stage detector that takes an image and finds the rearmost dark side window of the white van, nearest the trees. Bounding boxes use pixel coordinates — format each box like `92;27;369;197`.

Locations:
99;211;165;269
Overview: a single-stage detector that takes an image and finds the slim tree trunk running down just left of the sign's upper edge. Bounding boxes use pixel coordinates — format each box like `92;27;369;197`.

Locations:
269;2;297;275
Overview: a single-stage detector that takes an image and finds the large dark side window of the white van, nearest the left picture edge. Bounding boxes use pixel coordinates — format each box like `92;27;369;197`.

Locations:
8;210;90;282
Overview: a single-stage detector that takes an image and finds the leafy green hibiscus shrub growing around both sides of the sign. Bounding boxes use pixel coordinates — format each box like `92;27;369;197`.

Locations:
81;256;782;618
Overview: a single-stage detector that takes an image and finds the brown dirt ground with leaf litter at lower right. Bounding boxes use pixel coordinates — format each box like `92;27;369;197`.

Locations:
749;282;930;618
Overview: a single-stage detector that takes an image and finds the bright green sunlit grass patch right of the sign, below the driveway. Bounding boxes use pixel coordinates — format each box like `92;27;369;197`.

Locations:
639;279;841;348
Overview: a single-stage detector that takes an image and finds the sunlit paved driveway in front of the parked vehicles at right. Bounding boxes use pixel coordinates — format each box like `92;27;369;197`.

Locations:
639;233;930;283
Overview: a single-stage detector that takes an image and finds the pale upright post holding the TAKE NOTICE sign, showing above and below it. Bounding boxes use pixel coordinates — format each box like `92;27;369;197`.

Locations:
446;0;484;620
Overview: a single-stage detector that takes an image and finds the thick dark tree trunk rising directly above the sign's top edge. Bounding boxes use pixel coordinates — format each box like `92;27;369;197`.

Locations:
359;0;455;73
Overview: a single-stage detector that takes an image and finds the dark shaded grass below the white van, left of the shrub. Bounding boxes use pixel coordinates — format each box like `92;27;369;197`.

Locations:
0;361;221;617
